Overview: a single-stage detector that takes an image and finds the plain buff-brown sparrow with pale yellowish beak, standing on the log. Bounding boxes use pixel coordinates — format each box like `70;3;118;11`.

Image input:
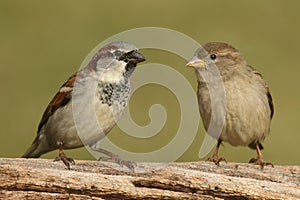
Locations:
187;42;274;168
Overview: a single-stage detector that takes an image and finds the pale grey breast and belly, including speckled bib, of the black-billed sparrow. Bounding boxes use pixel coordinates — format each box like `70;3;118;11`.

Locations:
43;79;130;148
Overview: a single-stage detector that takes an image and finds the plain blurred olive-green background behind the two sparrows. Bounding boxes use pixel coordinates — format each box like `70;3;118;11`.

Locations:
0;0;300;165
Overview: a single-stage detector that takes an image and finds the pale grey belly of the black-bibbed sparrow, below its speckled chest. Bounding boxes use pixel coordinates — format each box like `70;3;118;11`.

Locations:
45;103;124;149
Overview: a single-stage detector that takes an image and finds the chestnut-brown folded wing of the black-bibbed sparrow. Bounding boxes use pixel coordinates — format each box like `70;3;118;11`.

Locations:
37;73;78;133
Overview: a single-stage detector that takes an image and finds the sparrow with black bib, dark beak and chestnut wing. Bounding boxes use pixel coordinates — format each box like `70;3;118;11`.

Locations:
22;42;145;170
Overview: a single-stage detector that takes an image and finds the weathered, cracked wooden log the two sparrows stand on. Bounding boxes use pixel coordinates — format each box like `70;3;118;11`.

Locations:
0;158;300;199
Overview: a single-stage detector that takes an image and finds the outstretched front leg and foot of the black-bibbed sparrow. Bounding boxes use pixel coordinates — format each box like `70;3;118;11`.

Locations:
91;146;136;172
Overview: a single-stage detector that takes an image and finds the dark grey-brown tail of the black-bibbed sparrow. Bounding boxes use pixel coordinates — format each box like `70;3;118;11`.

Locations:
21;135;51;158
